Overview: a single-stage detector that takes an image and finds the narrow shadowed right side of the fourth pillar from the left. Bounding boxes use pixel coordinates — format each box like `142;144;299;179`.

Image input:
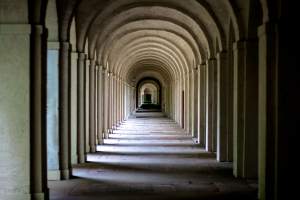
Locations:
89;60;96;153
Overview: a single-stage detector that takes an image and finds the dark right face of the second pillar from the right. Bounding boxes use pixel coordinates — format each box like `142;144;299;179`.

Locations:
243;41;258;178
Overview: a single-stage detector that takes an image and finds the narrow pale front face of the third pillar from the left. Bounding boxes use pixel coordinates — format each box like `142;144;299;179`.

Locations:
70;52;78;164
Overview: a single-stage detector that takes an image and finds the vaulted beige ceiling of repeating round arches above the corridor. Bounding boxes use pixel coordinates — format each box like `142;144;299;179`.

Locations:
54;0;264;85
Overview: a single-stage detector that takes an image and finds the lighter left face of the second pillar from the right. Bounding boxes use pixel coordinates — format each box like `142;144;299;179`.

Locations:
233;41;245;177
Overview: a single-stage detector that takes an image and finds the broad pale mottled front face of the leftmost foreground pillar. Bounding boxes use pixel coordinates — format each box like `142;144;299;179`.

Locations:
0;32;30;196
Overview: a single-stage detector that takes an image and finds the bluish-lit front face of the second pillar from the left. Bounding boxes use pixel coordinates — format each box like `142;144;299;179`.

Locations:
47;50;59;170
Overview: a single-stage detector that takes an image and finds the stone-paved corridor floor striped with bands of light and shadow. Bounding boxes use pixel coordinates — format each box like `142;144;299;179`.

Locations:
48;112;257;200
